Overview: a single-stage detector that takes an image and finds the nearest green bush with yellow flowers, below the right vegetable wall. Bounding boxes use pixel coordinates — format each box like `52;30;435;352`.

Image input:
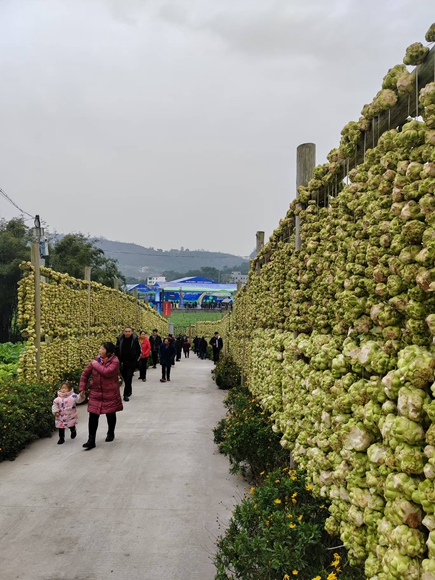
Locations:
214;468;365;580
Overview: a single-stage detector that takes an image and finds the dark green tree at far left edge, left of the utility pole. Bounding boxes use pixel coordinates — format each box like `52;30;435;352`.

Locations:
0;218;30;342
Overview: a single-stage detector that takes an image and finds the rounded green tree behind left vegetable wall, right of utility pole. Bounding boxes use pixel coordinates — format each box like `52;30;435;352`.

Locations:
49;233;125;287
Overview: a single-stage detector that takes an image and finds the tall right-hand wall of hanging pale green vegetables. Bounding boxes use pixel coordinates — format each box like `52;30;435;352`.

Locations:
229;31;435;580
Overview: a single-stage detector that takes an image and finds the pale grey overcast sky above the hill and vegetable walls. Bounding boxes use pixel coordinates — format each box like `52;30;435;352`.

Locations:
0;0;435;256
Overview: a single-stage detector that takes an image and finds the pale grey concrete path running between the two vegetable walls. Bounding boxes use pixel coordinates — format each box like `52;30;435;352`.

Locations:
0;354;246;580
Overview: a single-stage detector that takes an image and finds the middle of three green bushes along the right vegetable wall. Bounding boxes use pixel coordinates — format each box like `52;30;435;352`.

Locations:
213;385;289;478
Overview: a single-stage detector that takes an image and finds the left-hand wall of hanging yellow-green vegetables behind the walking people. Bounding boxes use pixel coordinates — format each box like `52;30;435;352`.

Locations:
18;263;168;383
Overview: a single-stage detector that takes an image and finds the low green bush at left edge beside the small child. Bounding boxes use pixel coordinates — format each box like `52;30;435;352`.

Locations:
0;380;56;461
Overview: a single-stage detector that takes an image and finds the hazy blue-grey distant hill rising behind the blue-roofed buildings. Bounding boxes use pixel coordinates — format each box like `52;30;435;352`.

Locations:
95;238;248;278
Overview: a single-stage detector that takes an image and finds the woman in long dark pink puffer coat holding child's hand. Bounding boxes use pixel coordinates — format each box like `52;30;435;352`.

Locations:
79;342;124;450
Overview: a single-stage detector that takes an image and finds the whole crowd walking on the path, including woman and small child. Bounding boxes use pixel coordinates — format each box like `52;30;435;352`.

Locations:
52;326;223;450
